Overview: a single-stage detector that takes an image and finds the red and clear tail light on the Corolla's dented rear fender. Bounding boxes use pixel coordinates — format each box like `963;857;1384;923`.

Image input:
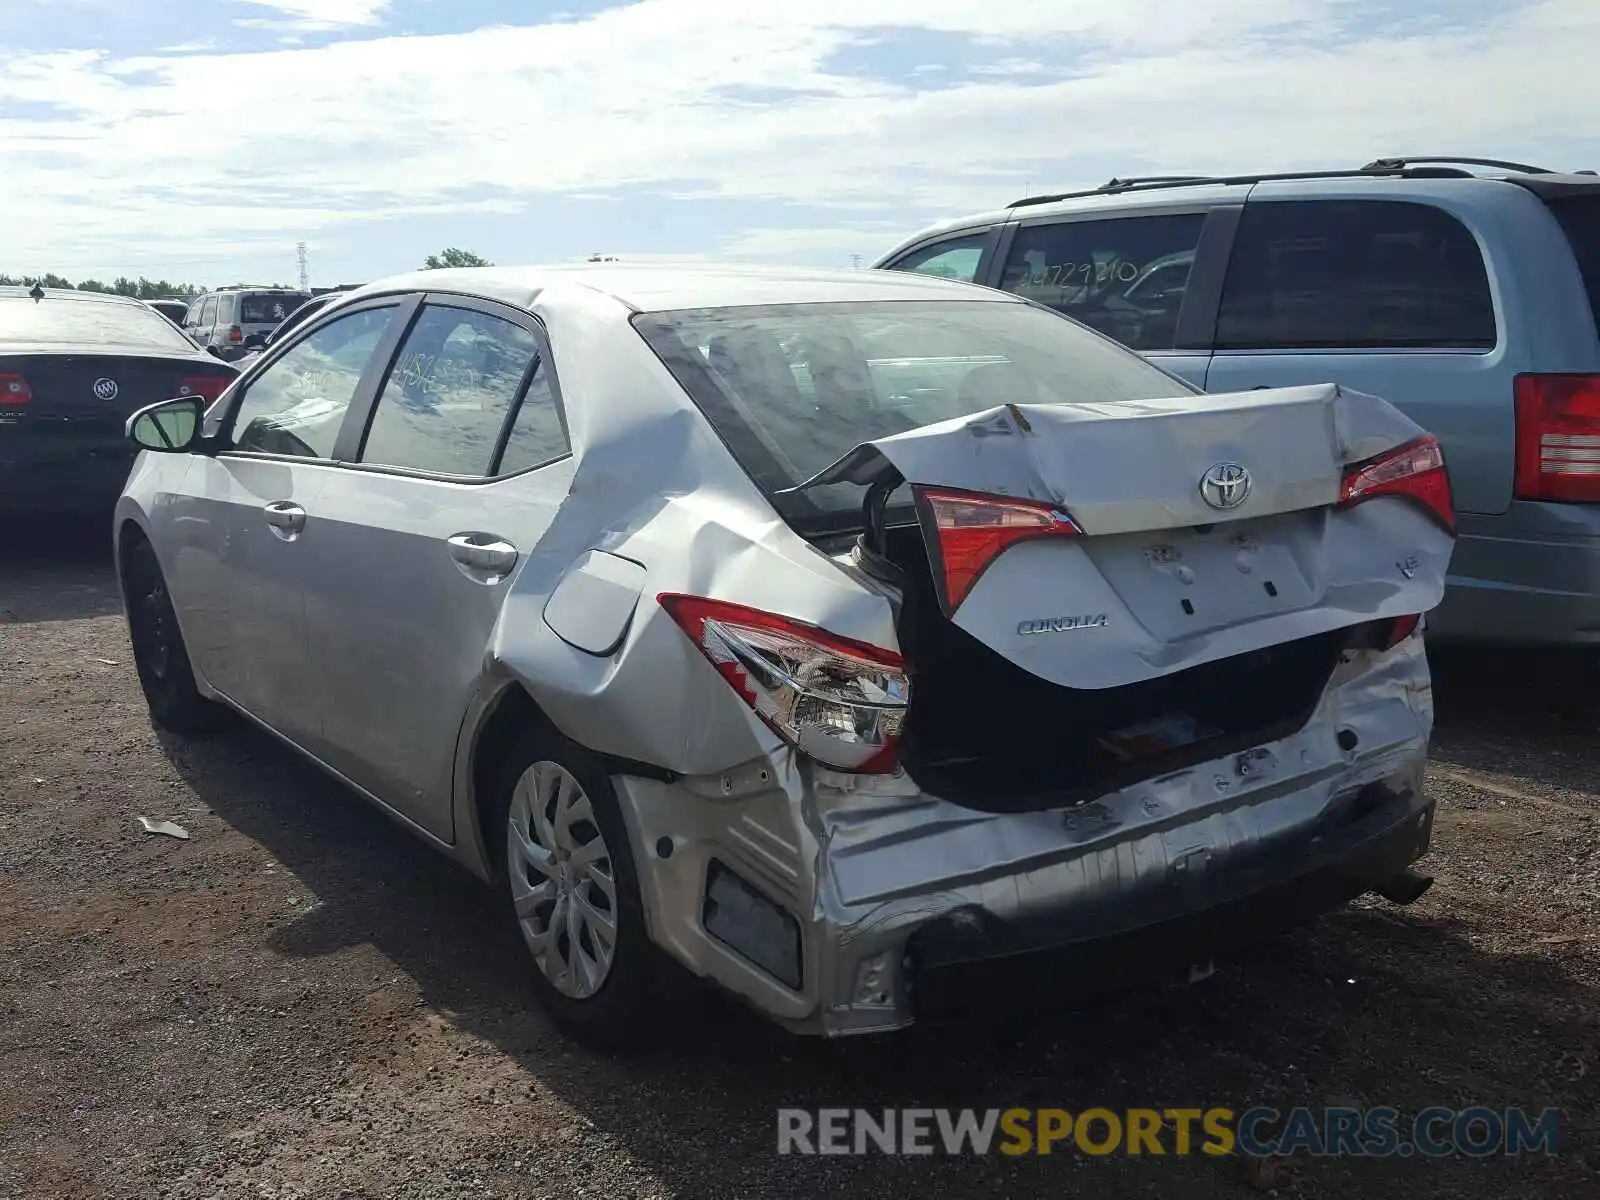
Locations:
659;592;910;774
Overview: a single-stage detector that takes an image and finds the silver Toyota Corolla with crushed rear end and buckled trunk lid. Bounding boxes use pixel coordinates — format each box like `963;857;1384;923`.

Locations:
117;264;1454;1045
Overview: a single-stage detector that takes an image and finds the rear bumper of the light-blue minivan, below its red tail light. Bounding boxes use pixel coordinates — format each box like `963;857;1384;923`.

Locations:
1427;501;1600;648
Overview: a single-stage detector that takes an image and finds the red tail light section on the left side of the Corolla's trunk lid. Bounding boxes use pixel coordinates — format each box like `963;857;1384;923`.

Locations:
915;488;1083;613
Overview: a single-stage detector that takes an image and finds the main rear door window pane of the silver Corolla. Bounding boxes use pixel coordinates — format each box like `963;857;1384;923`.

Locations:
362;304;539;477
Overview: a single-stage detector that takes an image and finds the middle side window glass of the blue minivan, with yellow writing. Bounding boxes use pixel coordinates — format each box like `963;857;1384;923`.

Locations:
1000;213;1205;350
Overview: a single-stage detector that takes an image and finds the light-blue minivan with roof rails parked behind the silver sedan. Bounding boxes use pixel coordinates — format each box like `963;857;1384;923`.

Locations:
875;158;1600;648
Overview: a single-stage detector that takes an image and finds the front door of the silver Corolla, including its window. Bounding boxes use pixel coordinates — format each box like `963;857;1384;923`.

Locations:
173;299;416;749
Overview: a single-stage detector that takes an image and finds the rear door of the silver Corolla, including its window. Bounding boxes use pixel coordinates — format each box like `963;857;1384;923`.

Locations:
302;296;573;842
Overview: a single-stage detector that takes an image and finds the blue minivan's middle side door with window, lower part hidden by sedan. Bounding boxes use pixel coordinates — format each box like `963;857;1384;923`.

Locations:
994;206;1232;387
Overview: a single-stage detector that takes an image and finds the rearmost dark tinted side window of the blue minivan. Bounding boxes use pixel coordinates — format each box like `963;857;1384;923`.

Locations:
1216;200;1496;350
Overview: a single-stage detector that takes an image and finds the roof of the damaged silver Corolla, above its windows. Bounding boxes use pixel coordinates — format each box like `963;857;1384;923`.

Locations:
341;261;1018;312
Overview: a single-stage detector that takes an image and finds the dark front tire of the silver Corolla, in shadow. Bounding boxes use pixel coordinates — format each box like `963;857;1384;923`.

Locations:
122;538;227;734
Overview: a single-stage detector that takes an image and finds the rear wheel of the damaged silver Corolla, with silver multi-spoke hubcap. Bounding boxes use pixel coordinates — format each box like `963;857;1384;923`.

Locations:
486;730;667;1051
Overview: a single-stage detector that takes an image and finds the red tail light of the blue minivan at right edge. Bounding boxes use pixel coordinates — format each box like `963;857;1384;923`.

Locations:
1514;374;1600;502
